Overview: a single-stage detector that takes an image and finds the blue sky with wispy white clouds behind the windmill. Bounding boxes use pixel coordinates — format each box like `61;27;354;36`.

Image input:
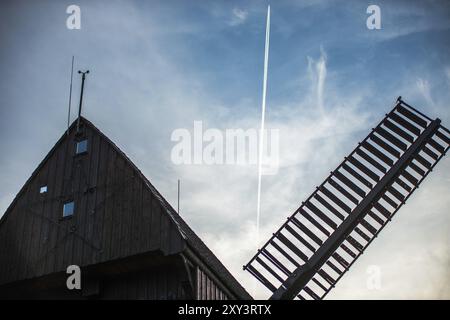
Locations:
0;0;450;298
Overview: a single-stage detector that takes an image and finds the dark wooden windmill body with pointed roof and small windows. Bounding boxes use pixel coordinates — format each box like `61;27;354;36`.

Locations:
0;118;251;299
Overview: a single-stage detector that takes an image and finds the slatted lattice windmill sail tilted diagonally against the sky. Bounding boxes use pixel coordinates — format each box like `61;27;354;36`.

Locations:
244;97;450;299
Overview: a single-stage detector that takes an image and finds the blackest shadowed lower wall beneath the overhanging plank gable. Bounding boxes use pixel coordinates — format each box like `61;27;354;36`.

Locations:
0;253;191;300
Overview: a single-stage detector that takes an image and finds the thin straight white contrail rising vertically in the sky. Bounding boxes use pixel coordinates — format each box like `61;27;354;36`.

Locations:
256;5;270;242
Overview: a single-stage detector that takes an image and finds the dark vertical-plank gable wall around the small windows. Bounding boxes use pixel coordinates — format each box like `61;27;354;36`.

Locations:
0;119;183;284
